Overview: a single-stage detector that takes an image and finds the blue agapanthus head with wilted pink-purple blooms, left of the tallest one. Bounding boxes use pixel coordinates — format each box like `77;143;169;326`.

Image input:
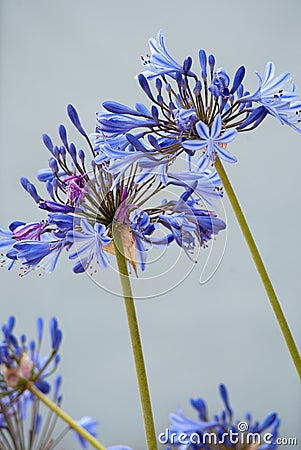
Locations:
0;101;226;276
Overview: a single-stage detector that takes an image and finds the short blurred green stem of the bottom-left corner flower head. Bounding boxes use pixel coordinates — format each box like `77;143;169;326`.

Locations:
26;382;106;450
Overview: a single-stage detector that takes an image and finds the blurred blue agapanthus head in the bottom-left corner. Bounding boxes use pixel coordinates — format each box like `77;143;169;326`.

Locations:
0;317;131;450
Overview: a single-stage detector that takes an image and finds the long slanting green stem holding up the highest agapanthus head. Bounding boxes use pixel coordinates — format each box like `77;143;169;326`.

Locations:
215;158;301;379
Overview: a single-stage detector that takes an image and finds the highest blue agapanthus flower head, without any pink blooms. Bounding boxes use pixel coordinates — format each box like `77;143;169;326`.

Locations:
95;31;301;176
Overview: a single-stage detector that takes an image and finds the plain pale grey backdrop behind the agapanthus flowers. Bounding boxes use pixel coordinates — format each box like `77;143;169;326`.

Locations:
0;0;301;450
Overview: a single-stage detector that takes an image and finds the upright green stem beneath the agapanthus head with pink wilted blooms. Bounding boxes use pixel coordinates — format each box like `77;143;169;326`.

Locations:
113;222;157;450
